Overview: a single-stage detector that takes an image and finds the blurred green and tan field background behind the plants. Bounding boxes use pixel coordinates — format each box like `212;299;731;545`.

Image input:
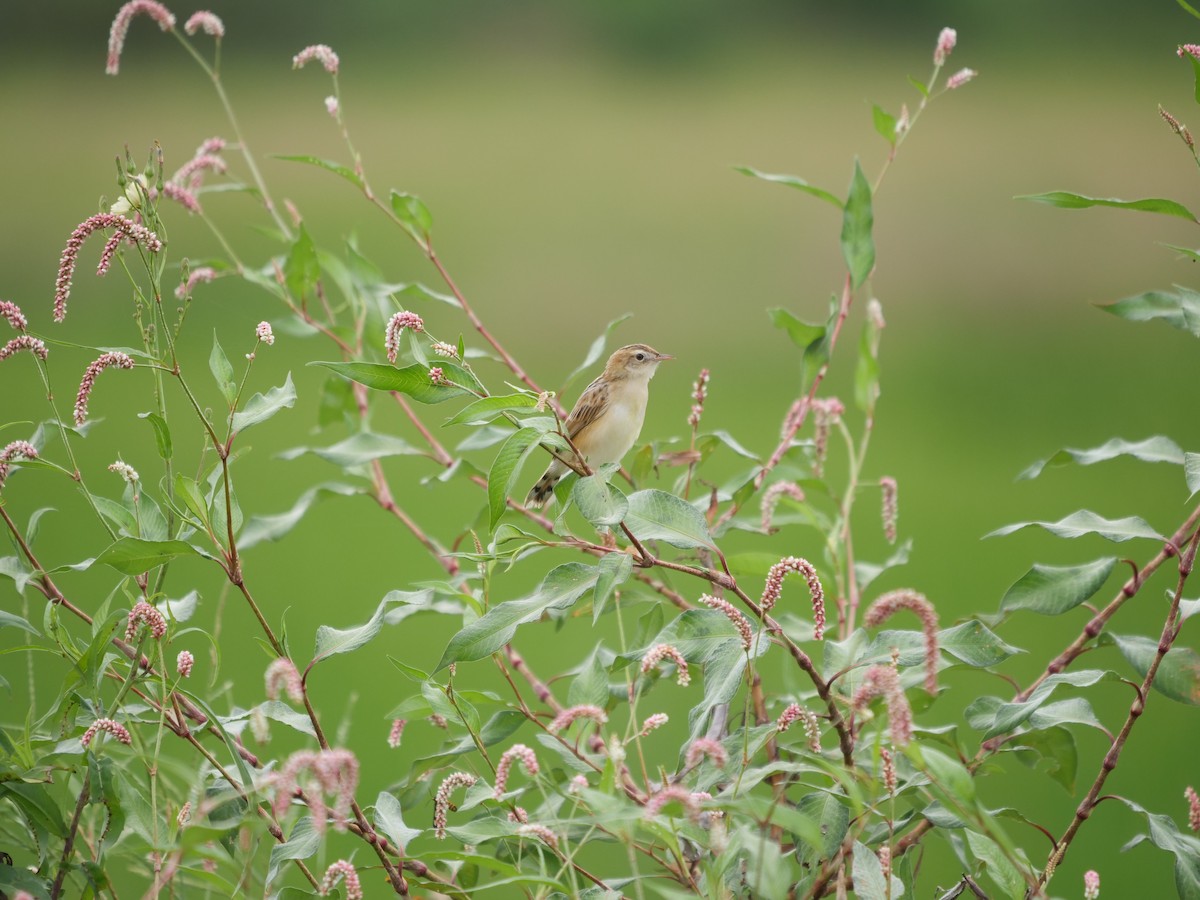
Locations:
0;0;1200;898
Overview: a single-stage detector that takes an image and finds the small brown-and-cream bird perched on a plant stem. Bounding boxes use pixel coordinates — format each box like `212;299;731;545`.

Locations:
526;343;674;509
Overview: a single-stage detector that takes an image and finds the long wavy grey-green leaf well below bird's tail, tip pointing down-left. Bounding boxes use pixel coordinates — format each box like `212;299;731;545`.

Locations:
433;563;599;673
